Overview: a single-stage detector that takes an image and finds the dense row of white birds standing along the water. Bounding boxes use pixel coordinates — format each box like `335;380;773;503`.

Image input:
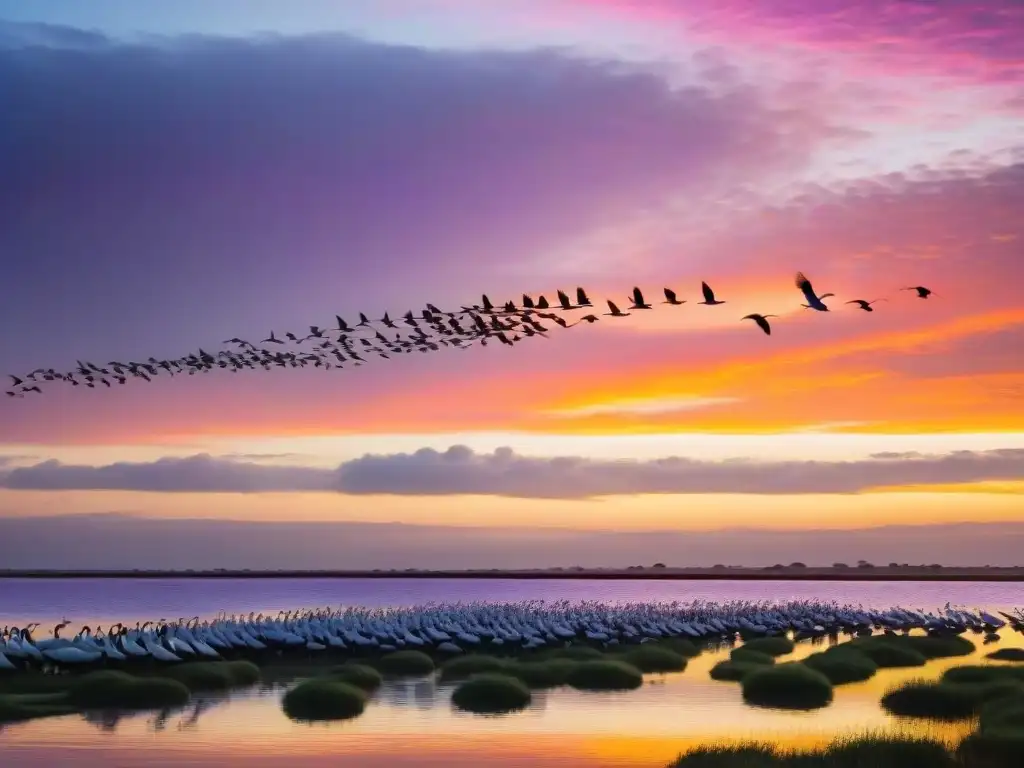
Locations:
0;601;1024;671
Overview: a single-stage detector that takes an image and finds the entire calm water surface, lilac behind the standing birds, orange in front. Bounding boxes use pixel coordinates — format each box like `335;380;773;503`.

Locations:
0;580;1024;768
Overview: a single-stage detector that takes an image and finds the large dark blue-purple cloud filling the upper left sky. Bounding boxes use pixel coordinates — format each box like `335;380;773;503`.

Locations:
0;25;820;370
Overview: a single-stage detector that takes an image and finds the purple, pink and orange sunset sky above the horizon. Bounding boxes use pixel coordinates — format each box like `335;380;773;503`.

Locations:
0;0;1024;567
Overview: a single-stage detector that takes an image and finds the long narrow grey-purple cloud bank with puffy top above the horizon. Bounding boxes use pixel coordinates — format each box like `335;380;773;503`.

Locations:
0;445;1024;500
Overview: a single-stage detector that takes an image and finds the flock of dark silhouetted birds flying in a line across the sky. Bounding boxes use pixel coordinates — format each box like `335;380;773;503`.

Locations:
6;272;932;397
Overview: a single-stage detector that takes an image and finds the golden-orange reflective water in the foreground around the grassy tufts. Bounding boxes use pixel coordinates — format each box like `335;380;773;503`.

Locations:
0;633;1024;768
